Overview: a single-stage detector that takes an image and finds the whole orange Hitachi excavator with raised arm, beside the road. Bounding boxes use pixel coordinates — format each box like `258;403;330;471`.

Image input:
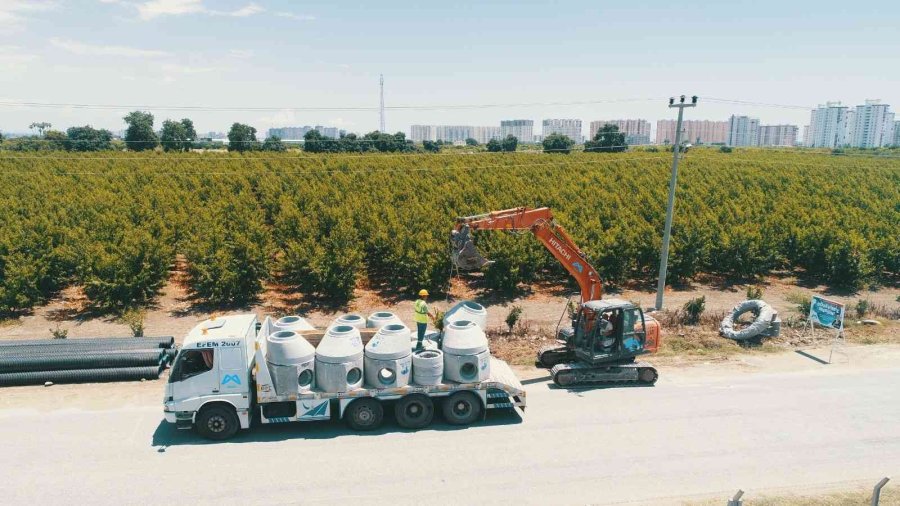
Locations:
450;207;659;387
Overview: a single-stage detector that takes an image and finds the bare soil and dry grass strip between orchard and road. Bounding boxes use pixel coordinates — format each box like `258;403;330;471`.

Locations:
0;271;900;365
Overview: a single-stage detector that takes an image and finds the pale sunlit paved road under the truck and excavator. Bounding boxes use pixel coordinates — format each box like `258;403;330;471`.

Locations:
0;367;900;504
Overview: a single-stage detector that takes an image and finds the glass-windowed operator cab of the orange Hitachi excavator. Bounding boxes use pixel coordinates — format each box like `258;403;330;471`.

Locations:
569;299;652;365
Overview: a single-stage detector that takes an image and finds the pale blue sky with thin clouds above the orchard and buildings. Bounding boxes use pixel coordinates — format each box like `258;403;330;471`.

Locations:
0;0;900;134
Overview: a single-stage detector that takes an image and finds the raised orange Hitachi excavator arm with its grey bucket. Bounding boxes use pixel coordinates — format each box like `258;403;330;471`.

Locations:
451;207;603;303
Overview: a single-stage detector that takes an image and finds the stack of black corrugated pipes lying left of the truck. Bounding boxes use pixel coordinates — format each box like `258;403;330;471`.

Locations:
0;337;177;386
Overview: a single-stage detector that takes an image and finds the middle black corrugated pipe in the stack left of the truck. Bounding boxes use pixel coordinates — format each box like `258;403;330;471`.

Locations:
0;349;166;373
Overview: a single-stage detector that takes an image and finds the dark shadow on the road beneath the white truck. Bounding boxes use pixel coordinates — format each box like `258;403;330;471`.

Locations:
151;409;522;453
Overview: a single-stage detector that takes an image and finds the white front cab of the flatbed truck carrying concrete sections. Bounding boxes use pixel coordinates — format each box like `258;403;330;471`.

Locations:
163;314;257;439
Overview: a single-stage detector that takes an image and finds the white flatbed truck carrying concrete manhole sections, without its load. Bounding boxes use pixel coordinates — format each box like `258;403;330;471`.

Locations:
163;314;525;439
